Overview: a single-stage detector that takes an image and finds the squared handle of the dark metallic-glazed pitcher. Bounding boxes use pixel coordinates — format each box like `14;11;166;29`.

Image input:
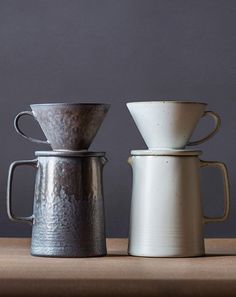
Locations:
7;159;37;224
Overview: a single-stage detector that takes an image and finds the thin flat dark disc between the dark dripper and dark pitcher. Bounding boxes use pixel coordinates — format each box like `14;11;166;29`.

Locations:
35;150;106;157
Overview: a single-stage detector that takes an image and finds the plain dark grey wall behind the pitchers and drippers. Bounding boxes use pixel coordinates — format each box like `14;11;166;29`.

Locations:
0;0;236;236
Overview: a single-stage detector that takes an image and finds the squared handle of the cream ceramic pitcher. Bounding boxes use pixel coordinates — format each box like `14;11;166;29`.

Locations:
200;160;230;224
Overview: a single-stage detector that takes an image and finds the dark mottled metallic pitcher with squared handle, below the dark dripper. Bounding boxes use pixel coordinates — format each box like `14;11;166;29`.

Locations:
7;152;107;257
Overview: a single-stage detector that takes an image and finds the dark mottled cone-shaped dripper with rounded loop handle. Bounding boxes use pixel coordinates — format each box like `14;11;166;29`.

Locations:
14;103;110;151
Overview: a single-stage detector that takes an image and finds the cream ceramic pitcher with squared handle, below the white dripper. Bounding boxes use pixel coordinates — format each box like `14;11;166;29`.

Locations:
128;150;230;257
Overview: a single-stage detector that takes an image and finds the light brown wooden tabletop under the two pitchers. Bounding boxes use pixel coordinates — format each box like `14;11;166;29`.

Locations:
0;238;236;297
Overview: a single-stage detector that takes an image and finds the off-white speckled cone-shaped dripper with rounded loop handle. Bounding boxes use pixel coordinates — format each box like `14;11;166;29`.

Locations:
127;101;220;149
